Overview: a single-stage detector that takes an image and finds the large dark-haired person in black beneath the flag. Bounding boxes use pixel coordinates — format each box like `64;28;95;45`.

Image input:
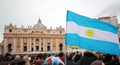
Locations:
77;51;98;65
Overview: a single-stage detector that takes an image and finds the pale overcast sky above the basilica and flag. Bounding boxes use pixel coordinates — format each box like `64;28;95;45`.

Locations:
0;0;119;41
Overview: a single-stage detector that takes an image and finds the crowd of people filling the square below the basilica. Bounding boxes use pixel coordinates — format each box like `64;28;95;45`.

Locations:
0;51;120;65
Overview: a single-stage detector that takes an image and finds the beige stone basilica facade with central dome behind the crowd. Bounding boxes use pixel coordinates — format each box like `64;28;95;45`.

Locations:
3;19;65;54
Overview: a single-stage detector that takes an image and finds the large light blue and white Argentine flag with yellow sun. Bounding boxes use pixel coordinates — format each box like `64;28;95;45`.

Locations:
65;11;120;55
